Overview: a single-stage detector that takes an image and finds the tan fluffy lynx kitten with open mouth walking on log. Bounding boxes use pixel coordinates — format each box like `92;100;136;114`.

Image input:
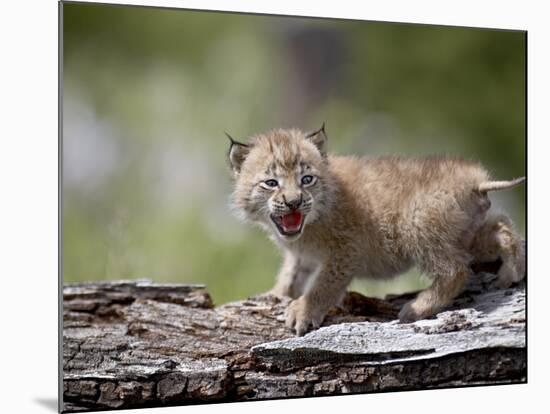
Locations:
229;125;525;335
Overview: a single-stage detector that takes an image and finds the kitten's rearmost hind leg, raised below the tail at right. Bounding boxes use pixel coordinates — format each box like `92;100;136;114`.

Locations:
472;215;525;288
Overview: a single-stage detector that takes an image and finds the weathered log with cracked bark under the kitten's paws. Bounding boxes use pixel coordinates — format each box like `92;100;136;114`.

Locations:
63;273;526;411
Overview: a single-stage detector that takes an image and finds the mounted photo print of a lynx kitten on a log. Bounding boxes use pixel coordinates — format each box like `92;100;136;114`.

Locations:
60;2;527;412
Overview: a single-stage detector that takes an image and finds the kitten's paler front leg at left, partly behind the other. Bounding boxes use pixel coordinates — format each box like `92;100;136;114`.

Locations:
270;252;315;299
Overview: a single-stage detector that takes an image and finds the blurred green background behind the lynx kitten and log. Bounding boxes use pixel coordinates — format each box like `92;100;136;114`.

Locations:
63;3;526;304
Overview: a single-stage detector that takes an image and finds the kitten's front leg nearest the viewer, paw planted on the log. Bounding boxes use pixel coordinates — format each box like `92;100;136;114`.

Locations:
286;262;352;336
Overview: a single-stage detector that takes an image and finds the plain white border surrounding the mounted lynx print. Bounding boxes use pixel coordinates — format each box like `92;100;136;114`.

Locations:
0;0;550;414
